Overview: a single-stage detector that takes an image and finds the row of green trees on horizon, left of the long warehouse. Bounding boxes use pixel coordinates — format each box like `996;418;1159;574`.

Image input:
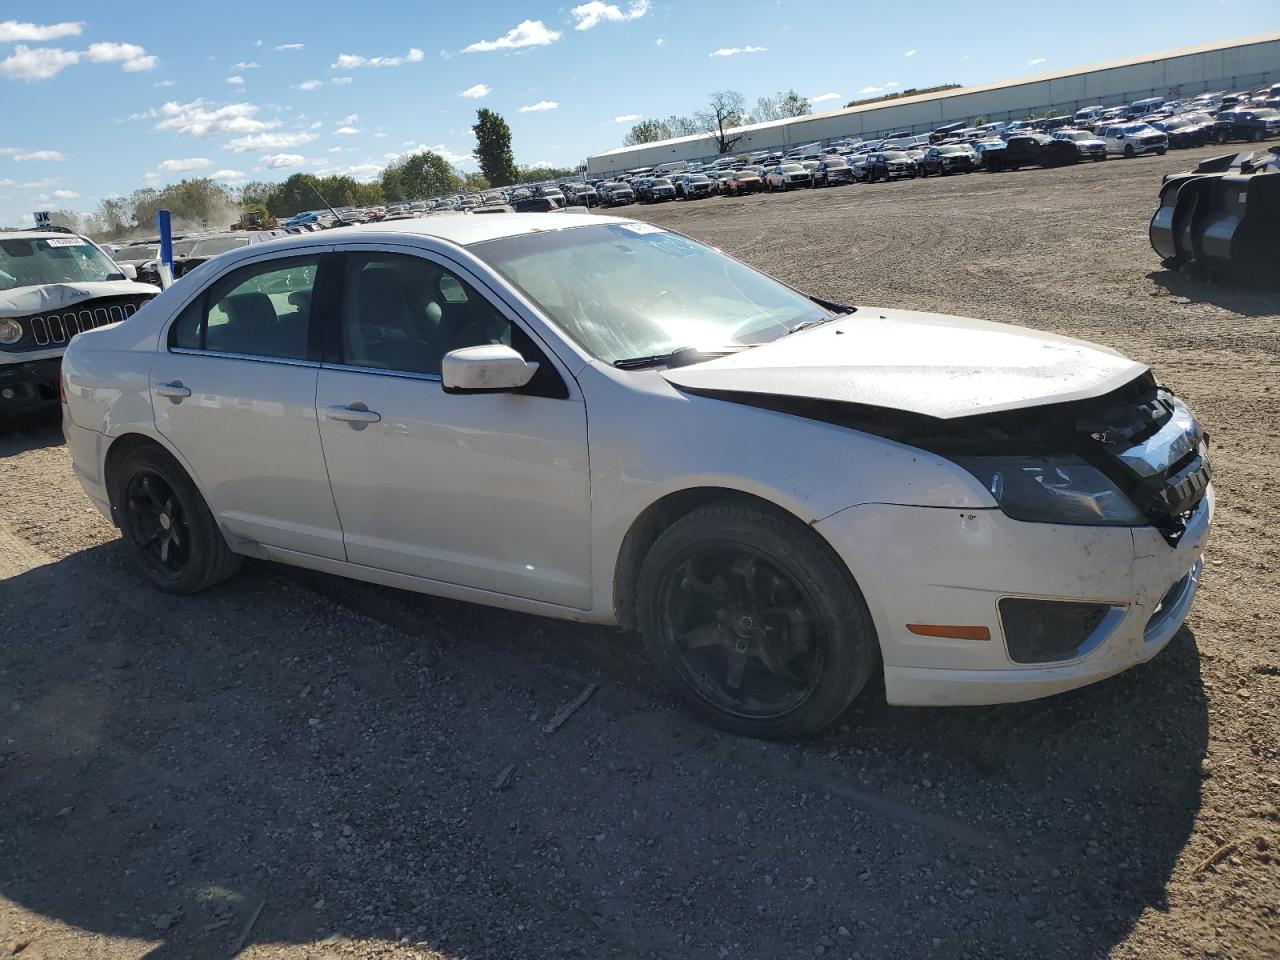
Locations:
88;109;577;239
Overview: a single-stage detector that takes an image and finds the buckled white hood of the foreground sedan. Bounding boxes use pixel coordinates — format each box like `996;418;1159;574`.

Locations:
663;307;1147;419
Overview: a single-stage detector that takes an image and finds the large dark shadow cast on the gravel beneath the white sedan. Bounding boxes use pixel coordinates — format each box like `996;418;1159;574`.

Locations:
0;543;1208;960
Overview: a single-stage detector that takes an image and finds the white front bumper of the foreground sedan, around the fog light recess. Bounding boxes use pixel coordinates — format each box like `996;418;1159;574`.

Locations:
817;486;1213;705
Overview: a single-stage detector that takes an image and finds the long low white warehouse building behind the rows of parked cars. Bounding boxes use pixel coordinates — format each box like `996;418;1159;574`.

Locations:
586;33;1280;177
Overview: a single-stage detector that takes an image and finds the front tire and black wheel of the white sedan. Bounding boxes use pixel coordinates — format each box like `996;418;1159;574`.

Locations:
636;503;878;740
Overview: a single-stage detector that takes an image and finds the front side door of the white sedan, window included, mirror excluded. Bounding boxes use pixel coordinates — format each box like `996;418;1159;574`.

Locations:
316;247;591;608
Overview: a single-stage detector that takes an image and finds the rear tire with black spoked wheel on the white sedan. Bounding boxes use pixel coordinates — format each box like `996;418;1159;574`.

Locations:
108;444;242;594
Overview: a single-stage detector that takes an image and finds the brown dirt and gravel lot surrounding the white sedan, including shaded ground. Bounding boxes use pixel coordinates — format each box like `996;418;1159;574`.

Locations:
0;144;1280;960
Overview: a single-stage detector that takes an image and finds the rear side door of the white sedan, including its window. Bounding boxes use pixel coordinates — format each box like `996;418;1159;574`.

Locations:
151;247;344;559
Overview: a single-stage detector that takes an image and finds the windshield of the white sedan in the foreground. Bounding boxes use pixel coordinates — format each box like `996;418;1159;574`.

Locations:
470;223;829;364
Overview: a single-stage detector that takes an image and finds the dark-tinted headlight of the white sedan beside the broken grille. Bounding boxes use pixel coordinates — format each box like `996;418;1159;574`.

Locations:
956;457;1147;526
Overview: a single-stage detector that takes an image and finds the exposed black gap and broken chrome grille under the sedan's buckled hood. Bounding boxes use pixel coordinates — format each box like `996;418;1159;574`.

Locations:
681;371;1212;545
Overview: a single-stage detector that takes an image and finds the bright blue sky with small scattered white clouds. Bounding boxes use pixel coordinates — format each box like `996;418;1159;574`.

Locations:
0;0;1280;225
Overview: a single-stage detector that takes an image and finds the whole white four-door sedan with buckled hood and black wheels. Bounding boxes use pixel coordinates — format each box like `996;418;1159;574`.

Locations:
63;214;1213;737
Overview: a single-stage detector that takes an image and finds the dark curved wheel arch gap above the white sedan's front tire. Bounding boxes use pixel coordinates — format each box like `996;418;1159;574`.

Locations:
613;485;860;630
